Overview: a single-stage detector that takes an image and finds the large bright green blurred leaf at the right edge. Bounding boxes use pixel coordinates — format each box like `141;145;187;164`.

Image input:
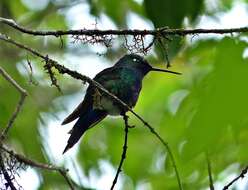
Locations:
174;38;248;171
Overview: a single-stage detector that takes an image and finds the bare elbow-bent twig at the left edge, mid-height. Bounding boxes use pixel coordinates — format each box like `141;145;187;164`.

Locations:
0;67;27;140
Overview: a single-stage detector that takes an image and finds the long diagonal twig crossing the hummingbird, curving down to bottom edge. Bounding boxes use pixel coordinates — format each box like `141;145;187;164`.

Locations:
0;34;183;190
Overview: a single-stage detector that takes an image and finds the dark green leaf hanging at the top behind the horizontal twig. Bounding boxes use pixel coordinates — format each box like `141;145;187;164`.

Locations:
144;0;203;59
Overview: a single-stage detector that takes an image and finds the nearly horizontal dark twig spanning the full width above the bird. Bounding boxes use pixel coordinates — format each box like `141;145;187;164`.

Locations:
0;17;248;37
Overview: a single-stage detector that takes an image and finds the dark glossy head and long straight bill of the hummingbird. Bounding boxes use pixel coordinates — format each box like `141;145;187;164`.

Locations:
115;54;181;75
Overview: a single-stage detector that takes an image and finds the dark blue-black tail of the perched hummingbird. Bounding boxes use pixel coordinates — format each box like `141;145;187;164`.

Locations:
63;110;107;154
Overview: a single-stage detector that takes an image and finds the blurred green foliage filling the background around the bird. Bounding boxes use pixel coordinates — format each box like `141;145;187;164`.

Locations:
0;0;248;190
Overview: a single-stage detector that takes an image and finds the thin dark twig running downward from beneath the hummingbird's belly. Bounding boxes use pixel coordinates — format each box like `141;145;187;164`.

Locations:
110;114;129;190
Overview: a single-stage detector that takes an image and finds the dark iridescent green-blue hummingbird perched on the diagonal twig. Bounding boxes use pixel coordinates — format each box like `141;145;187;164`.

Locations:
62;54;181;154
